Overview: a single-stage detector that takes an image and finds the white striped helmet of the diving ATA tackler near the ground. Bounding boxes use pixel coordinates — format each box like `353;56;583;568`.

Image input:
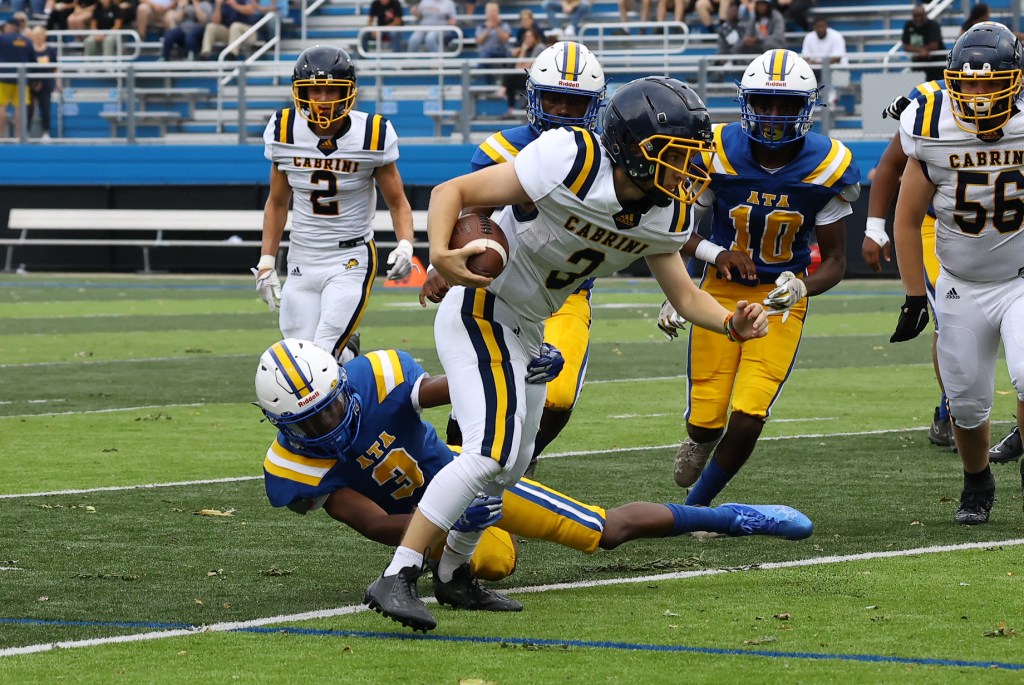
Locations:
256;338;359;454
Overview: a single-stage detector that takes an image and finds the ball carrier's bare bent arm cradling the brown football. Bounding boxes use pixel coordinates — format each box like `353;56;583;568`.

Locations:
427;164;530;288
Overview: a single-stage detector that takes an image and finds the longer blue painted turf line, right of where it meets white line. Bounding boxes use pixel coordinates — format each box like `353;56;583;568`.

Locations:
233;627;1024;671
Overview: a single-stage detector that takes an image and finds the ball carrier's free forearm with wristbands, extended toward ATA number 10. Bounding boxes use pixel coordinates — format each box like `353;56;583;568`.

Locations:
647;252;768;342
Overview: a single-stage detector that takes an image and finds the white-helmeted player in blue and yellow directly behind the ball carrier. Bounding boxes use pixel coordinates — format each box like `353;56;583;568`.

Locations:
420;41;605;477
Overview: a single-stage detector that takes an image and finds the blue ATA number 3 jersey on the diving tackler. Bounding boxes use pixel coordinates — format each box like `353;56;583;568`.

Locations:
263;350;454;514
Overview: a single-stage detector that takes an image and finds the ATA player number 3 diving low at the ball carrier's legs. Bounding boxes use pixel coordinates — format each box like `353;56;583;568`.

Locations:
256;339;813;611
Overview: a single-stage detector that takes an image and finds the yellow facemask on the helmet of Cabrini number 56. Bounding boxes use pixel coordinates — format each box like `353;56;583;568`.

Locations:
943;63;1022;135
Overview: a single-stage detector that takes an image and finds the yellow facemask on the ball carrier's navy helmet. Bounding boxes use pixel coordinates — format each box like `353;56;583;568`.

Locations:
634;135;715;205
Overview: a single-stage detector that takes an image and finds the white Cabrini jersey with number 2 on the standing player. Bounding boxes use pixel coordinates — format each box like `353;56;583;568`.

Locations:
263;108;398;249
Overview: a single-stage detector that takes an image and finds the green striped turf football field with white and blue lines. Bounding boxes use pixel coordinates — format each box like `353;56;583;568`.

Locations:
0;275;1024;685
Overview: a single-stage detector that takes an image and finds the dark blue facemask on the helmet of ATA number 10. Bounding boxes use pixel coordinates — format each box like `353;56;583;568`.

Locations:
736;87;820;147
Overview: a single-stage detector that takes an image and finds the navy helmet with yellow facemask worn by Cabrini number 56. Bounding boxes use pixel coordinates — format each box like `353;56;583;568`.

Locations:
945;22;1024;135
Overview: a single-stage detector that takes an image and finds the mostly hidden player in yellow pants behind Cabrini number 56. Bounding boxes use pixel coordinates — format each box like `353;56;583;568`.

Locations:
861;81;1024;463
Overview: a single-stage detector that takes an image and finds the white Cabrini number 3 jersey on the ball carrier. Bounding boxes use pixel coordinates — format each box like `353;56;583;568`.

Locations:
488;128;692;322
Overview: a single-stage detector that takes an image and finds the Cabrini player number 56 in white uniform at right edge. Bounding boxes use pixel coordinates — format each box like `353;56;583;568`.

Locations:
895;22;1024;524
